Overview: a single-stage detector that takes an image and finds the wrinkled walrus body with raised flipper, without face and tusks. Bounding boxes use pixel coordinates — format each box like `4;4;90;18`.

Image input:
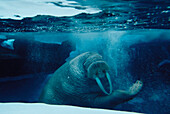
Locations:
39;52;143;109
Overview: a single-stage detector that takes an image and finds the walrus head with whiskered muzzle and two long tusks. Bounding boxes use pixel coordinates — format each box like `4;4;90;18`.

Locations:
84;54;113;95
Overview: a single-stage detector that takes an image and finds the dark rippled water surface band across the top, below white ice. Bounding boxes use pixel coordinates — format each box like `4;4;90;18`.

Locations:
0;0;170;32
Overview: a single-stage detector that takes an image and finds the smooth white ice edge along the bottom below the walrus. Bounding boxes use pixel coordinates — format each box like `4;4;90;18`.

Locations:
0;103;143;114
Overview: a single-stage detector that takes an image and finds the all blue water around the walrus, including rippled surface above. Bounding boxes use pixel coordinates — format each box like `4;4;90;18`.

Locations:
0;0;170;114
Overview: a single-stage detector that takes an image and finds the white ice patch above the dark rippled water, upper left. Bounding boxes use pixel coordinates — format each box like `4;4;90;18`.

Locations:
0;0;100;20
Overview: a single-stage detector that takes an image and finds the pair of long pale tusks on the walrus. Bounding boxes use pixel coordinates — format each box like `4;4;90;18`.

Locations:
95;72;113;95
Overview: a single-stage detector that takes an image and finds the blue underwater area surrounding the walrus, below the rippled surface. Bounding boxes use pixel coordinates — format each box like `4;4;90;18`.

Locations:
0;30;170;113
